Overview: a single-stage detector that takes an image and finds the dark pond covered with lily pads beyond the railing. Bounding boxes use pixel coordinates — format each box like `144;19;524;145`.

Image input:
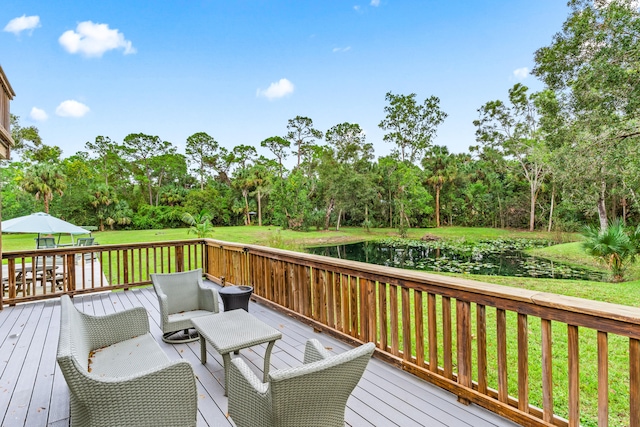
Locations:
306;239;607;282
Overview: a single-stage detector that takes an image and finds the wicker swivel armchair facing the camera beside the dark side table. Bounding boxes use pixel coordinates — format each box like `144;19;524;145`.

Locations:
151;268;218;344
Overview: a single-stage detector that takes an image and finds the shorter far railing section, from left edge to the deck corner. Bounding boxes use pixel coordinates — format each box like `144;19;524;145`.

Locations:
0;240;204;308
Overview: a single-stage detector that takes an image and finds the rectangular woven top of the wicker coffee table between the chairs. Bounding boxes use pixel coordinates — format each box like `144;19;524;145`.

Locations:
191;309;282;354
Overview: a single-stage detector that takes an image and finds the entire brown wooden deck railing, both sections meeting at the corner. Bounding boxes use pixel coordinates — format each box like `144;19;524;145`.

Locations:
0;239;640;427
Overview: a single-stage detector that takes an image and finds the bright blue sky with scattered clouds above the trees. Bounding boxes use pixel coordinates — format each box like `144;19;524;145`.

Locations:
0;0;569;166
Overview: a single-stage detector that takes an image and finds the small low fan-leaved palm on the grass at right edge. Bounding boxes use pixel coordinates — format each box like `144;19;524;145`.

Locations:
583;218;640;282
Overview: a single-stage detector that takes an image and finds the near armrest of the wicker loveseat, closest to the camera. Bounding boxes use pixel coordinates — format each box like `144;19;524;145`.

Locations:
67;360;198;426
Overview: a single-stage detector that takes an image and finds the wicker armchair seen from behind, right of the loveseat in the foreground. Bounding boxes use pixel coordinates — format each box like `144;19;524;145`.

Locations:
228;339;375;427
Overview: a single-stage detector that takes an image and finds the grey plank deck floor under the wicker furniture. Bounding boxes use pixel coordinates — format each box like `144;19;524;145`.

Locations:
0;285;515;427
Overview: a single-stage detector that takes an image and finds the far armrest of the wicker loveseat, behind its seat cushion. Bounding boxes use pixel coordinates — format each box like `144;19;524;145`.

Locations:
79;307;149;349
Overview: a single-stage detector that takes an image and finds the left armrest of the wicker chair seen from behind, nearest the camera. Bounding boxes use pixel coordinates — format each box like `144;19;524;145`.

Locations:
227;358;271;427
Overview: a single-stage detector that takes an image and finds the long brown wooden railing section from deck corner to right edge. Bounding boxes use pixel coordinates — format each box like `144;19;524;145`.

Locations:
205;239;640;427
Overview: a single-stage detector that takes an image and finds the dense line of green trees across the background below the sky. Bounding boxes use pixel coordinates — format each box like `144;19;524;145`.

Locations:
0;0;640;232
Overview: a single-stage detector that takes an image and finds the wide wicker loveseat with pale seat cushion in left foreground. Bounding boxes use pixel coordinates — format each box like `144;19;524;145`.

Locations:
57;295;198;427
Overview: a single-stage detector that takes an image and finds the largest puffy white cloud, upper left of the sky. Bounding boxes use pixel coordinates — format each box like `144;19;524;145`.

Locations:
58;21;136;57
